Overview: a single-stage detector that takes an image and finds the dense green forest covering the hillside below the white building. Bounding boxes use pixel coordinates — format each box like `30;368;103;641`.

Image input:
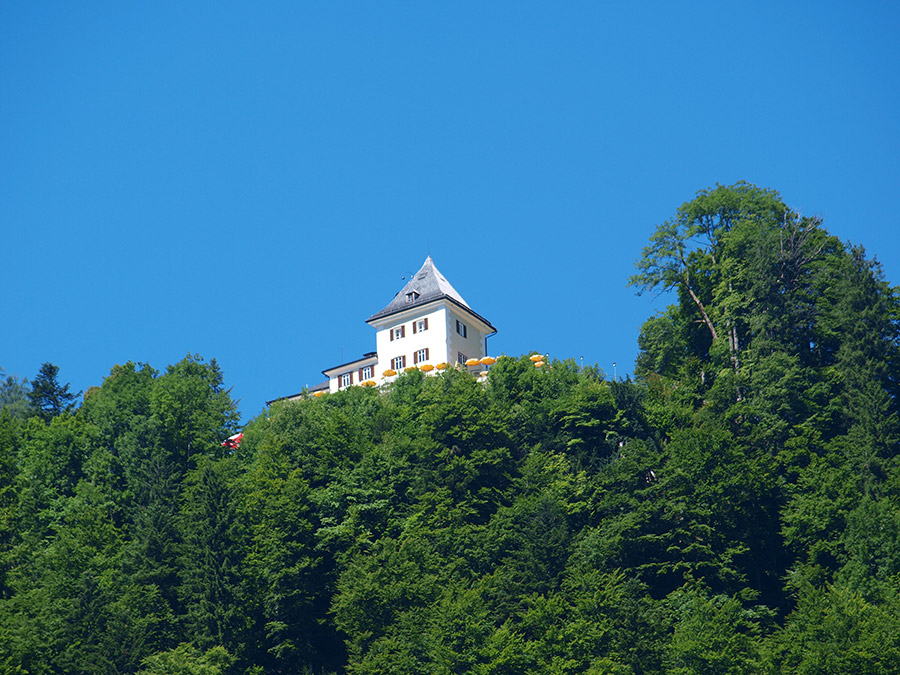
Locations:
0;183;900;675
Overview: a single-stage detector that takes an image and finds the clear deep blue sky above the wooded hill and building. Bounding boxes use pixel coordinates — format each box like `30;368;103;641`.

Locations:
0;1;900;419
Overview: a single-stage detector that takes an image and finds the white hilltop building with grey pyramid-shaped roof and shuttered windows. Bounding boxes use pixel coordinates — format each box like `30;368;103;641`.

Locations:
320;256;497;398
